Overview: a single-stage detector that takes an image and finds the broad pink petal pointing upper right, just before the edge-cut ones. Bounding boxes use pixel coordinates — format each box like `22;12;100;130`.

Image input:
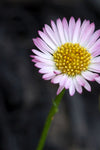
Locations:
80;23;95;46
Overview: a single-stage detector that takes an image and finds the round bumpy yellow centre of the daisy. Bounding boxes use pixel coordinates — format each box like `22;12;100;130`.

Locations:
53;43;91;76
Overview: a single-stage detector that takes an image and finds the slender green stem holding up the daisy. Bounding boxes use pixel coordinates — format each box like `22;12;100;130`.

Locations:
36;89;65;150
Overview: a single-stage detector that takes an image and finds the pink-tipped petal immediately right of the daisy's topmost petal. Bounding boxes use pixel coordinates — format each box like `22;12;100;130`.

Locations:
73;18;81;43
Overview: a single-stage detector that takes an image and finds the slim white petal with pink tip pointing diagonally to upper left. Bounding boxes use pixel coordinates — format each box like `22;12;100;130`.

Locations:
38;31;57;50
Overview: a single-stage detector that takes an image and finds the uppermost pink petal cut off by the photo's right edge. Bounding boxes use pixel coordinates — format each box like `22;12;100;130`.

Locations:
86;30;100;49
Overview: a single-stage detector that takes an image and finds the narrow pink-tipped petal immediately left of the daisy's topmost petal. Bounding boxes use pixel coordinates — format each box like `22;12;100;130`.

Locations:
62;18;69;42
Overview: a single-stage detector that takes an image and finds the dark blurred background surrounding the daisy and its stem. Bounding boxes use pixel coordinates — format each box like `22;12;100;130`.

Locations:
0;0;100;150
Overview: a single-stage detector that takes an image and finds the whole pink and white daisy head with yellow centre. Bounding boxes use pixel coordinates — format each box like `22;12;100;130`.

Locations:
31;17;100;96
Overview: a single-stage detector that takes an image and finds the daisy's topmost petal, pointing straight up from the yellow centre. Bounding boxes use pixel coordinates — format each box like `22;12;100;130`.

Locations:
69;17;75;42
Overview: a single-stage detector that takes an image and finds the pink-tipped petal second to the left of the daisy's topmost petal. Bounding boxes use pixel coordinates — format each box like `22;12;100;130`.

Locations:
57;19;66;44
